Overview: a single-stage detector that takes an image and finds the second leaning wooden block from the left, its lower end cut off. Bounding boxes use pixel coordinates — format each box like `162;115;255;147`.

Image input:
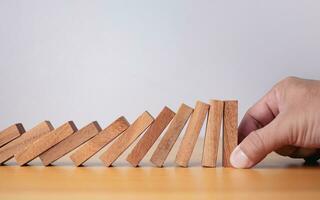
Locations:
0;121;54;164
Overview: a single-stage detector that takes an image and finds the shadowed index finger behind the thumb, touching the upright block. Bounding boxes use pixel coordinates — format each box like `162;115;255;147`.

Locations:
238;89;279;143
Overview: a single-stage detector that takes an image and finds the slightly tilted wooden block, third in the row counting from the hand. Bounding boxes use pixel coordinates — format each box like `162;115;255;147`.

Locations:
176;101;209;167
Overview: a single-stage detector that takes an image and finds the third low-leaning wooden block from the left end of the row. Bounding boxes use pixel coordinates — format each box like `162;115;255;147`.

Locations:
14;121;77;166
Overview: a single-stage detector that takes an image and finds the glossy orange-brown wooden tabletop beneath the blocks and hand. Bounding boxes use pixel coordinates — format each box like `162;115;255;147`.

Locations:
0;139;320;200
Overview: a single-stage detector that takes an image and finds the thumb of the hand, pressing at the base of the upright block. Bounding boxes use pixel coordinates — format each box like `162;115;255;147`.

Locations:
230;115;289;168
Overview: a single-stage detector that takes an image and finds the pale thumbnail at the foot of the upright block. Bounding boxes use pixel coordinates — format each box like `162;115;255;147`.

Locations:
230;146;253;168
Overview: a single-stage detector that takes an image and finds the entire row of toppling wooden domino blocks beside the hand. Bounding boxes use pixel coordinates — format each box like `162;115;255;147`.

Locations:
0;100;238;167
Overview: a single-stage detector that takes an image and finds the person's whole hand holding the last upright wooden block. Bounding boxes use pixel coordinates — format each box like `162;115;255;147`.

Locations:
230;77;320;168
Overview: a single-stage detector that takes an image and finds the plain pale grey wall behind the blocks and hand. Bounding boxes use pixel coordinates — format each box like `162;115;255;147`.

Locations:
0;0;320;134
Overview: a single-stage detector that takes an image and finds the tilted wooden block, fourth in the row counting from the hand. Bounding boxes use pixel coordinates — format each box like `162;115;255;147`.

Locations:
150;104;193;167
